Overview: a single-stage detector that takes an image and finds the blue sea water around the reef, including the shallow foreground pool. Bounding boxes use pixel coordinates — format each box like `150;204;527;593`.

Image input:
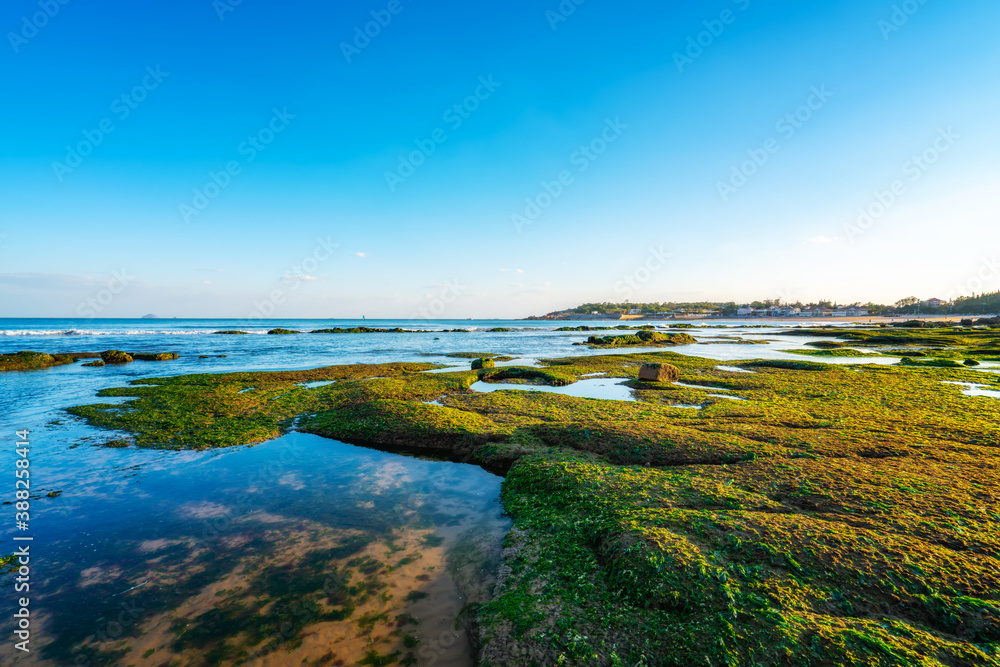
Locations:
0;319;988;666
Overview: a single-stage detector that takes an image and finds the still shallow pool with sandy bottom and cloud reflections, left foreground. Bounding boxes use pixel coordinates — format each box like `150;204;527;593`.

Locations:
0;433;509;667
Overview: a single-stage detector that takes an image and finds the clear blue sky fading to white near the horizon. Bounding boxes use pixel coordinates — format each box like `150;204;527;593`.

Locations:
0;0;1000;318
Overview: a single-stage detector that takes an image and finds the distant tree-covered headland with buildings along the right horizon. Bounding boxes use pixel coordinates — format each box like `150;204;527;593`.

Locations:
525;291;1000;320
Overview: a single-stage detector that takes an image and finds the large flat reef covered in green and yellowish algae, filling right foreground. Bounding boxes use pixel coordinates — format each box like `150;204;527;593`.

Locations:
64;330;1000;665
